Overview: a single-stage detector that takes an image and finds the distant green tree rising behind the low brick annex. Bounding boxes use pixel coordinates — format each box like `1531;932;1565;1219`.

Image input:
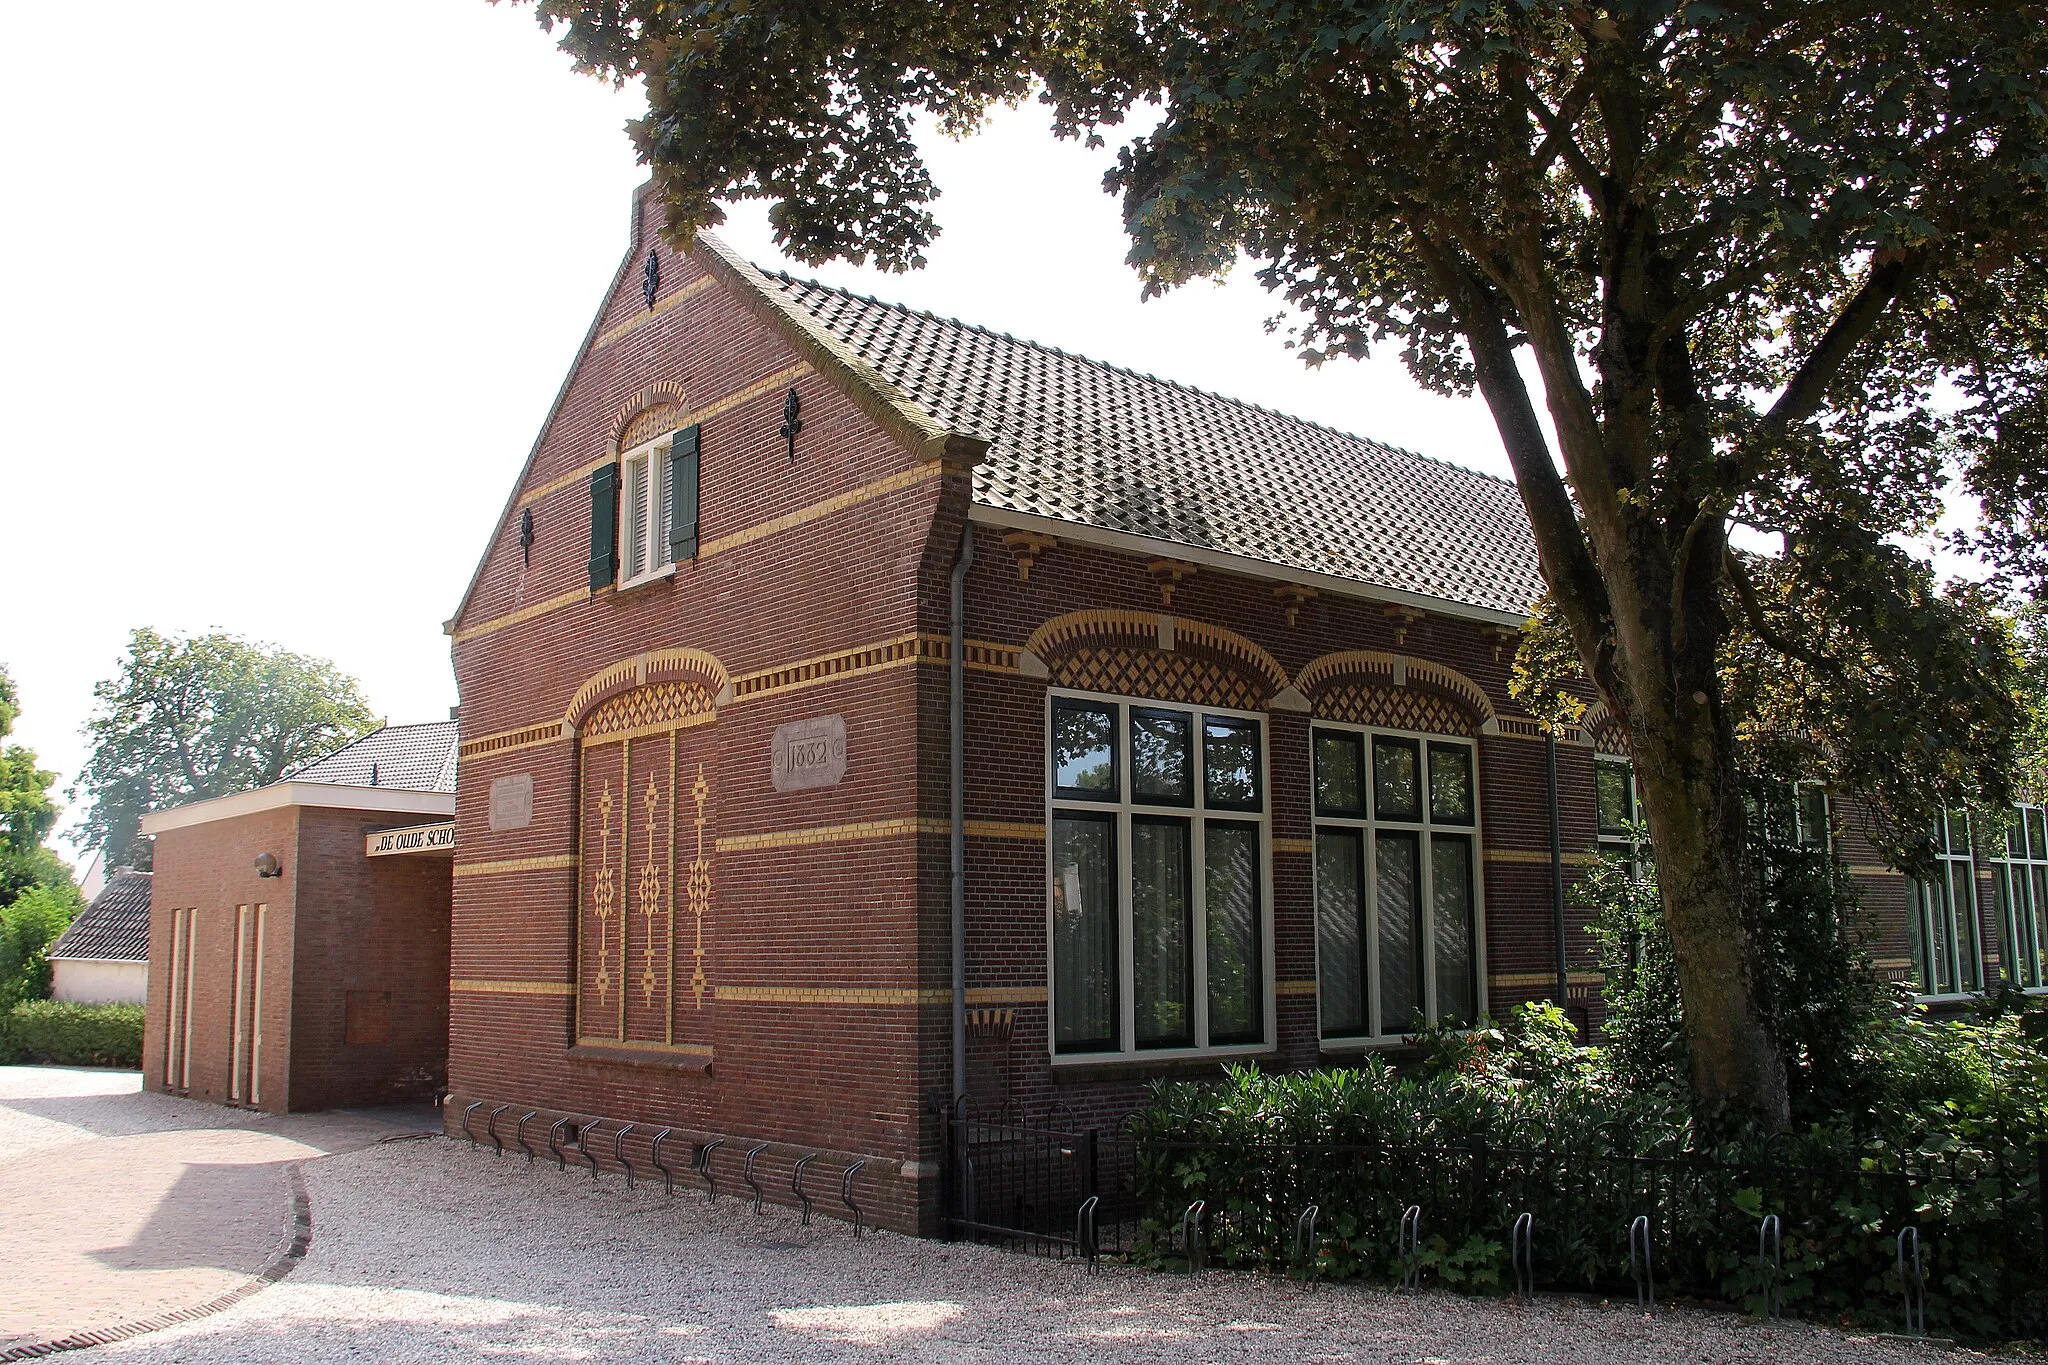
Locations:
72;628;379;862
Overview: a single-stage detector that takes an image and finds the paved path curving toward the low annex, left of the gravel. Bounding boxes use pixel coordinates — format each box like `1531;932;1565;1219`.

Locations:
0;1066;424;1357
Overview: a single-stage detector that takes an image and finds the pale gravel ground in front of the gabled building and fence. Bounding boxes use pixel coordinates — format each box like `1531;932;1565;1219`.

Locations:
56;1138;1990;1365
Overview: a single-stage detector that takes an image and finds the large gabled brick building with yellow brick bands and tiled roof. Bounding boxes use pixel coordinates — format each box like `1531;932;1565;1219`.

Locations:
449;184;2039;1228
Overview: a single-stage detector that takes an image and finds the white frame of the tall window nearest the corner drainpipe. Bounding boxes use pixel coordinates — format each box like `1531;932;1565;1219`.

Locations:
1038;688;1278;1066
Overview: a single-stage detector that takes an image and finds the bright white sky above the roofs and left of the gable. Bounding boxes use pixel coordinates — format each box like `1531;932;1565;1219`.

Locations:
0;0;1505;855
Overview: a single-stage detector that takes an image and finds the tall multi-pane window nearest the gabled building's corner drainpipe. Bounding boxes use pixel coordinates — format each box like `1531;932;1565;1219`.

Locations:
1049;696;1268;1054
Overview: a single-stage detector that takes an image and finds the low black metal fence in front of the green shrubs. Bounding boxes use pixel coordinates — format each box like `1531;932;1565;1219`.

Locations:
946;1117;2048;1340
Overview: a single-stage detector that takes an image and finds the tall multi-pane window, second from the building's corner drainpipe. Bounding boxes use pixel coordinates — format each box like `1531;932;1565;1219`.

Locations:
1315;724;1479;1038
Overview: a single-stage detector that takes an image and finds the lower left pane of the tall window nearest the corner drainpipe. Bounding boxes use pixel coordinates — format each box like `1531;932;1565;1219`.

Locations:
1053;814;1118;1052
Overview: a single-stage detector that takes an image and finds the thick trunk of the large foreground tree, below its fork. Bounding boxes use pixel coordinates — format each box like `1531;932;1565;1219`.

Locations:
1624;665;1790;1132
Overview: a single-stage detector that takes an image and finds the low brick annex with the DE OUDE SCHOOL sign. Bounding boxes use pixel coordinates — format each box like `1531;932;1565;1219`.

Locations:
145;720;457;1113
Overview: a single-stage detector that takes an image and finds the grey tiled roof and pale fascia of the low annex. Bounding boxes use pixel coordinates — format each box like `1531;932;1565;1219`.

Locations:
141;720;457;835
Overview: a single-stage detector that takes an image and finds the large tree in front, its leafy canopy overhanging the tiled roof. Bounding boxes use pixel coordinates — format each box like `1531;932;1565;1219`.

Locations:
512;0;2048;1124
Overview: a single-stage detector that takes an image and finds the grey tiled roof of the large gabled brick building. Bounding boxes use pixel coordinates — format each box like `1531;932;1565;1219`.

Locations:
768;274;1542;614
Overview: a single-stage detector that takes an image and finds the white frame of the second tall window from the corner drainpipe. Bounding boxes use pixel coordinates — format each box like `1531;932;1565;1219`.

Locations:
1309;720;1491;1052
